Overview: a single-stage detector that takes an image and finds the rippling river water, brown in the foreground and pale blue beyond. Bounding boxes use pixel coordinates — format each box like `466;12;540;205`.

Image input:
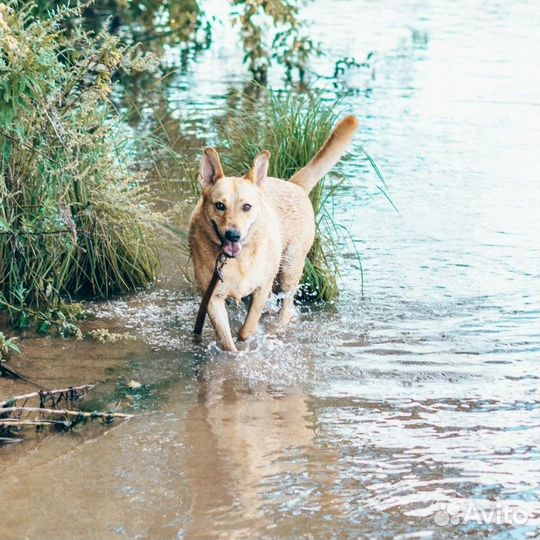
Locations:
0;0;540;540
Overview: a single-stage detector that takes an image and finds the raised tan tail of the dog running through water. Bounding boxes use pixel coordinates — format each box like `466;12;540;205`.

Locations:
290;114;358;193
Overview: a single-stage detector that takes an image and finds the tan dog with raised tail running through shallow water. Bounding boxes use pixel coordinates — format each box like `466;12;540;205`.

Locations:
189;116;358;352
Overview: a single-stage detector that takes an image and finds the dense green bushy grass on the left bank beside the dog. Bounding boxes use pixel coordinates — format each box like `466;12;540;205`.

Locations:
0;1;162;333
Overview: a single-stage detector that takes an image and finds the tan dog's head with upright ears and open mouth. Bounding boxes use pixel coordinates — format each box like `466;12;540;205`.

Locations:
199;148;270;257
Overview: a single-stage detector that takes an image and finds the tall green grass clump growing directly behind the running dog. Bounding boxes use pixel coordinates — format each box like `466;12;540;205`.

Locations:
219;90;361;300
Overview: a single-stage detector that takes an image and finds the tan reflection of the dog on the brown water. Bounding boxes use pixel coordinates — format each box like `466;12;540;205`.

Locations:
186;363;314;539
